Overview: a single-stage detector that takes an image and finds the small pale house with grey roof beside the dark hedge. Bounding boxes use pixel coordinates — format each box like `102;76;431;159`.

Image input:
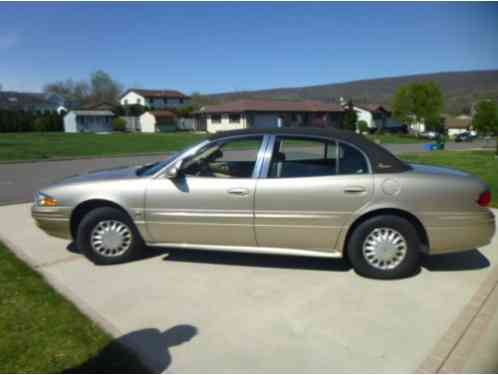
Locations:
64;110;114;133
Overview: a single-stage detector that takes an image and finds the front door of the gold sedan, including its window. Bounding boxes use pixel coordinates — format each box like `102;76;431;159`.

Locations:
145;136;263;246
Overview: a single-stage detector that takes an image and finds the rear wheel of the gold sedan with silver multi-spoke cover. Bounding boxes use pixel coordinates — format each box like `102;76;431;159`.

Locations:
347;215;421;279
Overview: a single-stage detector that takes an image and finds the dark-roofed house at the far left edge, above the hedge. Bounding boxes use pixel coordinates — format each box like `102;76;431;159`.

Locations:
0;91;67;114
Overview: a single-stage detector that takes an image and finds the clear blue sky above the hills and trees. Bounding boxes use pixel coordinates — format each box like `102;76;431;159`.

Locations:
0;2;498;94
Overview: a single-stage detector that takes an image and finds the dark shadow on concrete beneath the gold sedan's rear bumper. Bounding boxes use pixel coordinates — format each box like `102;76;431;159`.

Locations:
422;249;491;271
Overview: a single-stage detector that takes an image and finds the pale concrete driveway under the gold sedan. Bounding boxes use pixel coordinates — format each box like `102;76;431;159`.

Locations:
0;205;498;372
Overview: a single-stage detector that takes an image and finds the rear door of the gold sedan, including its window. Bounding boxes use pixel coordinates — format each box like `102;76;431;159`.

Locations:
255;136;373;251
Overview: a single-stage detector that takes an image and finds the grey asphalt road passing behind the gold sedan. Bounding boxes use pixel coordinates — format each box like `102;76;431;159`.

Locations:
0;142;492;204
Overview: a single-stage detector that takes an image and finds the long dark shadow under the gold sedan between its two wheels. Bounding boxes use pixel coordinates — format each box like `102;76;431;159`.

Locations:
160;249;351;271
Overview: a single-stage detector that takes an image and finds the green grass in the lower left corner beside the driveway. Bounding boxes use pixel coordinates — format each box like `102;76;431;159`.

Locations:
0;243;147;373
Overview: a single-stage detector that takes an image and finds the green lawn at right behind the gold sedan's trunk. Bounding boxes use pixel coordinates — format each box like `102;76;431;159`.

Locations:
400;151;498;208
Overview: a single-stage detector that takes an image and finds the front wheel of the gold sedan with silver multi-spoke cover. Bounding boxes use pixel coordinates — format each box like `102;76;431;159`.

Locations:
76;207;144;265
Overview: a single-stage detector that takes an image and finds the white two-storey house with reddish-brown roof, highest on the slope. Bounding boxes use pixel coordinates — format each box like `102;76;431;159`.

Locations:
119;89;192;110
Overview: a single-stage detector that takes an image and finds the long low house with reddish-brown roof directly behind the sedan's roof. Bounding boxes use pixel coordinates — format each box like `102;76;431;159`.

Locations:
195;99;344;133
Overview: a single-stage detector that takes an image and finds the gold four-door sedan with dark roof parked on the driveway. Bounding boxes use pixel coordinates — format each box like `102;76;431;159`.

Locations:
32;128;495;278
